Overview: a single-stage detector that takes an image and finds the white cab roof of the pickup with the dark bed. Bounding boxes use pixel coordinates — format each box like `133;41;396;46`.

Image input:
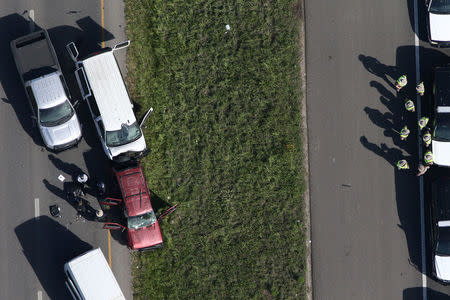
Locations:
30;72;67;109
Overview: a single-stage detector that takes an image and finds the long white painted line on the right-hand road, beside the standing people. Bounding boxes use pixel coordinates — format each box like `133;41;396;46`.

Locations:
414;0;428;300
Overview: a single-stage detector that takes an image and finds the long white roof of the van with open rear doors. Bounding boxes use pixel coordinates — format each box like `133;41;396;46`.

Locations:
83;51;136;131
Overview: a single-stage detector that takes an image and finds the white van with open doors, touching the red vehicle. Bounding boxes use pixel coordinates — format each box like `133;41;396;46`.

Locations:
66;41;152;161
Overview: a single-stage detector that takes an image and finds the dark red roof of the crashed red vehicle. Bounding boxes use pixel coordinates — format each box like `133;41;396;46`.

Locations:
115;164;153;217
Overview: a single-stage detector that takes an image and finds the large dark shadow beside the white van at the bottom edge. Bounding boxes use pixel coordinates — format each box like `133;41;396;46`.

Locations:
14;216;92;299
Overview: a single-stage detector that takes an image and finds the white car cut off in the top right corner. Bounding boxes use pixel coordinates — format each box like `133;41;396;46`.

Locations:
425;0;450;47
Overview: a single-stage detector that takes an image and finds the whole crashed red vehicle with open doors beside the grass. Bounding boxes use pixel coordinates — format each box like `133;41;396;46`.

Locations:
103;163;163;250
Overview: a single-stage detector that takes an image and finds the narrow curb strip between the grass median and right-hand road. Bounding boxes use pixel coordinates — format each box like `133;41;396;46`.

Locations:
298;0;313;300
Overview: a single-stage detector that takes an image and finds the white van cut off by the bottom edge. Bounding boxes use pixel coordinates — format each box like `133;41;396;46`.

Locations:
64;248;125;300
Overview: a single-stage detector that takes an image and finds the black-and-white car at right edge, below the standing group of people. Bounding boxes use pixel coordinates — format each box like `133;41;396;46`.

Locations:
429;177;450;283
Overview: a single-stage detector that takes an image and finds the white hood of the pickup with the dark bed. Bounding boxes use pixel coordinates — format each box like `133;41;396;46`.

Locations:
40;114;81;148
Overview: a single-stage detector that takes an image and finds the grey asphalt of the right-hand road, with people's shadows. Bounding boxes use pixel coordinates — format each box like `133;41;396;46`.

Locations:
305;0;450;300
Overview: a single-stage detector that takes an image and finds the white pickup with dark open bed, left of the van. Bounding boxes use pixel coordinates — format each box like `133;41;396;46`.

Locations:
11;30;81;150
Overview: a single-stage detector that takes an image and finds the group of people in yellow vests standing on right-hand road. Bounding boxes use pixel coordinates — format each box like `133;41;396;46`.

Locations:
395;75;433;176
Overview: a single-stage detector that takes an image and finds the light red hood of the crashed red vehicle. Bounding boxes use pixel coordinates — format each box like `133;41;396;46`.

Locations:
128;221;163;250
